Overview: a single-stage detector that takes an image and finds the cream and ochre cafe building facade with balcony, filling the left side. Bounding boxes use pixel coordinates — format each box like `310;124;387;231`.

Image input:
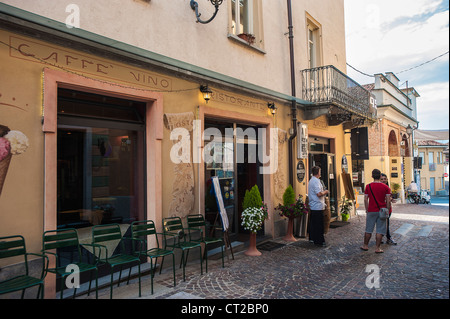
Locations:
0;0;376;298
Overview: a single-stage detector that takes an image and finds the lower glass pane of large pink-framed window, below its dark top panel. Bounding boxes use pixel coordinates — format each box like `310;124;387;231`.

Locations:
58;126;144;228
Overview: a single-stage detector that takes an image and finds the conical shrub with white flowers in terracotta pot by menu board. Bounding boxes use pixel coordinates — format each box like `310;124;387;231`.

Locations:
242;185;268;256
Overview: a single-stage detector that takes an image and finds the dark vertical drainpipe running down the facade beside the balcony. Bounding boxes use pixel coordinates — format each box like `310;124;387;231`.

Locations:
287;0;297;186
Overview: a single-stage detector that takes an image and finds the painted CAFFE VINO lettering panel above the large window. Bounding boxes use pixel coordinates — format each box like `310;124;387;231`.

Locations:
10;36;172;90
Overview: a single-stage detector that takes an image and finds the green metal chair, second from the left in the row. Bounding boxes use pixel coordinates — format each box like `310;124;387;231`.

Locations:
42;228;98;299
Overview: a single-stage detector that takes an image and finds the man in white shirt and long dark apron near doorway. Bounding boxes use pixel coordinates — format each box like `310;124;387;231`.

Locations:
308;166;328;246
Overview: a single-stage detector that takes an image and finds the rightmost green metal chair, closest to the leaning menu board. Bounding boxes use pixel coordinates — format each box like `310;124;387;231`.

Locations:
187;214;225;272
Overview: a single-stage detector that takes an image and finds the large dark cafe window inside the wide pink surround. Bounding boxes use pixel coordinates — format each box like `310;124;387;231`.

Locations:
57;89;146;231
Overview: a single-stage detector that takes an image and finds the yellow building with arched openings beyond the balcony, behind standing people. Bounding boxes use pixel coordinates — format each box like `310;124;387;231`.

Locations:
353;72;420;201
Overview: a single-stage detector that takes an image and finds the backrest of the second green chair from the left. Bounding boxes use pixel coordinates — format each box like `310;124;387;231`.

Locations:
42;228;81;266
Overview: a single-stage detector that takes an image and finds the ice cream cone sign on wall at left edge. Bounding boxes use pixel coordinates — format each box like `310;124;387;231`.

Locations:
0;125;28;196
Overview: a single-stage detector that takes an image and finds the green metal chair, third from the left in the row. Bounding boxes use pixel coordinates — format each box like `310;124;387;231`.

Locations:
92;224;141;299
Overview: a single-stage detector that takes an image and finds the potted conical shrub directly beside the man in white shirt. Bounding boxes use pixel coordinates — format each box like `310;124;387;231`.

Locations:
276;185;308;241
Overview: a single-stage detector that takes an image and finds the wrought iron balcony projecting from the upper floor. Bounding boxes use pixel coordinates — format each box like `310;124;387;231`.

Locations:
301;65;377;125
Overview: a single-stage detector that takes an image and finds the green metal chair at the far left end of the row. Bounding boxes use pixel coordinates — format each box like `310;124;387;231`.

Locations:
0;235;49;299
